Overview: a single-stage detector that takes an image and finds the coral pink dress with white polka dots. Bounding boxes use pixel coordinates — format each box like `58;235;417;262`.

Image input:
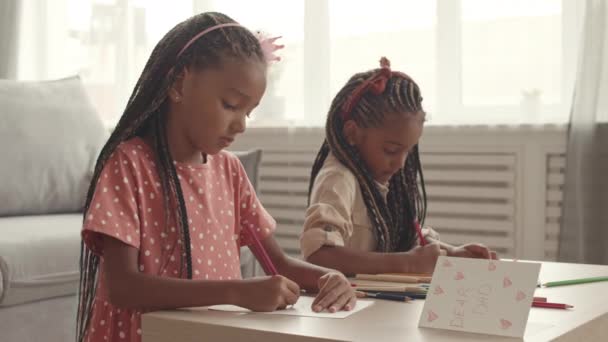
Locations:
82;137;276;341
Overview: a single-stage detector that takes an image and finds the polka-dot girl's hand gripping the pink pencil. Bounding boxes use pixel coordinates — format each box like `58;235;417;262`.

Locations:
235;275;300;312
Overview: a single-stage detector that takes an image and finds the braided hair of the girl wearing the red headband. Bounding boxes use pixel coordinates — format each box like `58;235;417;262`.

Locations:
308;59;426;252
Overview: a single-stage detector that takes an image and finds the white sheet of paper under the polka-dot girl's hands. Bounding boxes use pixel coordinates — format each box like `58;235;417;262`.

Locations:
202;296;374;318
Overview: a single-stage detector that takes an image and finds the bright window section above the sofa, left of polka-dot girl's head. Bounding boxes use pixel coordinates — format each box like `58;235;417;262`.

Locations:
18;0;192;125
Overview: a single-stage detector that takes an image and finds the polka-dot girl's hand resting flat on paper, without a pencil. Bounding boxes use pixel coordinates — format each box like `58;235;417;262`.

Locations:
312;271;357;313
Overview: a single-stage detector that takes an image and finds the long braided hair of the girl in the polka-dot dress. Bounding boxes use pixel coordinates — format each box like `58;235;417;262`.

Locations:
76;12;264;341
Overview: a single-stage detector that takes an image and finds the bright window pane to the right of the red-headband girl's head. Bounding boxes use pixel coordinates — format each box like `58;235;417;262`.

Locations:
462;0;562;106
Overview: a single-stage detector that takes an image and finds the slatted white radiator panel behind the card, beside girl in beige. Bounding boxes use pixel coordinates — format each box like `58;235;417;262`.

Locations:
421;152;517;256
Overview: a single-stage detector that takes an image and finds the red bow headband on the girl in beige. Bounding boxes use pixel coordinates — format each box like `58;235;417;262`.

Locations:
342;57;411;121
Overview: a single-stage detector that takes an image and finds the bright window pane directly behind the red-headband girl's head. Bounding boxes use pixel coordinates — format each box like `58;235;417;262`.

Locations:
329;0;437;111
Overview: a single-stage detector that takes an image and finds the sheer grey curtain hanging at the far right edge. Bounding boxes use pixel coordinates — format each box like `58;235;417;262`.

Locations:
559;0;608;264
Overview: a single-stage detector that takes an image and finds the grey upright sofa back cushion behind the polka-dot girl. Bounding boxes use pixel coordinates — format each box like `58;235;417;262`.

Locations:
0;77;108;216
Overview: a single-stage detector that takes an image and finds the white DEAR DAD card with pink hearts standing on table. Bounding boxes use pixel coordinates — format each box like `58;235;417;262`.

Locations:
418;256;540;337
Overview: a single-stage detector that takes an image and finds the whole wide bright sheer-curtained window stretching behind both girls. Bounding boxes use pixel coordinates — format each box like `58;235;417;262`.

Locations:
13;0;578;126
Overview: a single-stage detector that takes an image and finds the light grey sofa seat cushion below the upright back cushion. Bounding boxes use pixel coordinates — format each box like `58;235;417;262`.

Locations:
0;214;82;307
